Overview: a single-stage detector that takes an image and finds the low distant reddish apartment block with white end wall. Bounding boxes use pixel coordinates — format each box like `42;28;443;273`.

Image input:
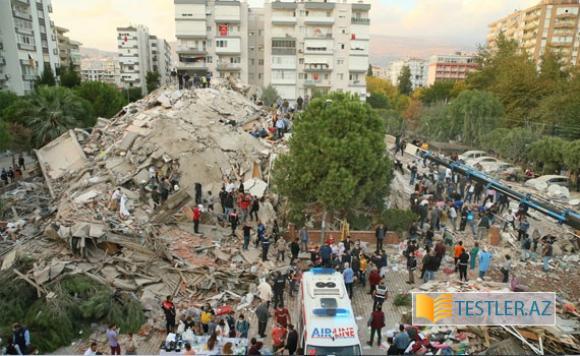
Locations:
427;52;479;86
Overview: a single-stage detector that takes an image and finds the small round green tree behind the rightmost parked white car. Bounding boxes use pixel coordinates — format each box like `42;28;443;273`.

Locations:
529;137;566;174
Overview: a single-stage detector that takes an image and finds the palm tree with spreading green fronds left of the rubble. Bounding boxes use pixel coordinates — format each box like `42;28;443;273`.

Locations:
23;86;91;147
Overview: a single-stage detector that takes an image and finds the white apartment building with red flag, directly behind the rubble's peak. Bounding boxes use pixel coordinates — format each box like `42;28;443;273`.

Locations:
174;0;248;83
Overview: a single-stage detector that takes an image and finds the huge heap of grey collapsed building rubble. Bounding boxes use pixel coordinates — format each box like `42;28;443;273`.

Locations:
2;80;292;354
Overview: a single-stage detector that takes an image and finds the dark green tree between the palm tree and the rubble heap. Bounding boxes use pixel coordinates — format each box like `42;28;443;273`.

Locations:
75;81;127;119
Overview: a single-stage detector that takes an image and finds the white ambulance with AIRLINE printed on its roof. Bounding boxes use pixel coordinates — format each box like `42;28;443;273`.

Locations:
297;268;362;356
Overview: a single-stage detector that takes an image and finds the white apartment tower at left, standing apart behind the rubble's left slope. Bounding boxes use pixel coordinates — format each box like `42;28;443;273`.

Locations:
117;25;171;94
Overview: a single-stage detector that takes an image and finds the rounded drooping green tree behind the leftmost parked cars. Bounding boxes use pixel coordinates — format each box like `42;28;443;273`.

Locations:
449;90;503;143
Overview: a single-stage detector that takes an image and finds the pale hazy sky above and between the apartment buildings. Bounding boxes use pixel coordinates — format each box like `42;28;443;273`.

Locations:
52;0;539;51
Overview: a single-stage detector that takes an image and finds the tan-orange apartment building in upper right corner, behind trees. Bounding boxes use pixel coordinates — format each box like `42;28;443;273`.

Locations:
487;0;580;66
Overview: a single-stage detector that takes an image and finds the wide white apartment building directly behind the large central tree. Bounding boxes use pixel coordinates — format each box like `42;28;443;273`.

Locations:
263;0;370;101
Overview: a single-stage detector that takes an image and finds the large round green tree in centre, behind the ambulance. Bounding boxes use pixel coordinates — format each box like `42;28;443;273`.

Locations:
273;93;392;222
